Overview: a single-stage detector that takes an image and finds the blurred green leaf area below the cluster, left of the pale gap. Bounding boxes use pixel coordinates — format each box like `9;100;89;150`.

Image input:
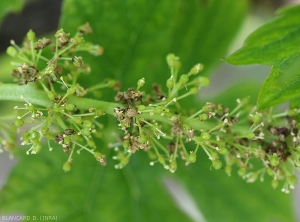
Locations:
0;147;189;222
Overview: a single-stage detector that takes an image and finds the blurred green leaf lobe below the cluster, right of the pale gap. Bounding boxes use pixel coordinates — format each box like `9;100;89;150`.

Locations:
176;158;296;222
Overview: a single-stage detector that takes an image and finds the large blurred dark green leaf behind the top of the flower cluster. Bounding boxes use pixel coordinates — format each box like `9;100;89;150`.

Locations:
60;0;247;92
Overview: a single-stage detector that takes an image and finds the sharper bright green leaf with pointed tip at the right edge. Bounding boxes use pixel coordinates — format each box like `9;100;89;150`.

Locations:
226;5;300;109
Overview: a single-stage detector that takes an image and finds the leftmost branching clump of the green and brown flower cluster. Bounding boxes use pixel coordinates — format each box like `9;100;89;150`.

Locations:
1;24;111;171
